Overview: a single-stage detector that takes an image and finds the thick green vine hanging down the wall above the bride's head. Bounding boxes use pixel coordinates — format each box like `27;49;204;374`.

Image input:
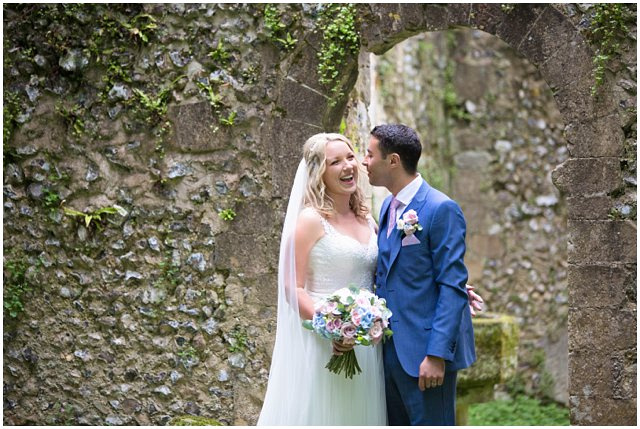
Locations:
318;3;360;106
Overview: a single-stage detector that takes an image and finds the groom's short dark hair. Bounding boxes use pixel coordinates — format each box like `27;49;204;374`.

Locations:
371;124;422;174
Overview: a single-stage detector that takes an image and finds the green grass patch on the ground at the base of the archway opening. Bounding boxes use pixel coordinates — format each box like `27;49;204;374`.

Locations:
468;395;569;426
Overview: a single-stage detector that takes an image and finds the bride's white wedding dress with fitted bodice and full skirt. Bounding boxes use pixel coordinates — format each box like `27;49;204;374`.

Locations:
258;219;387;426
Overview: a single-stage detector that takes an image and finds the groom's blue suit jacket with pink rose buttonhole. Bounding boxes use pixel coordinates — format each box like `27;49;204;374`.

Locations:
376;181;476;377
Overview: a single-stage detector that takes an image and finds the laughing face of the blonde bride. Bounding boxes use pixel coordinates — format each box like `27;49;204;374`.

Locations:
322;140;358;195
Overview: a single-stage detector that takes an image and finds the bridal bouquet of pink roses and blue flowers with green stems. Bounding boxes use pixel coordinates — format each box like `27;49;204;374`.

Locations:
302;287;393;378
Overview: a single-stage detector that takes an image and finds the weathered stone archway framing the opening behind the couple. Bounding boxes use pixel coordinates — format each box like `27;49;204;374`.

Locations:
278;4;636;425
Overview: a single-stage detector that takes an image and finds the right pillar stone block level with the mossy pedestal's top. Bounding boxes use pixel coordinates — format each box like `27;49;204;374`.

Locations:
568;307;636;352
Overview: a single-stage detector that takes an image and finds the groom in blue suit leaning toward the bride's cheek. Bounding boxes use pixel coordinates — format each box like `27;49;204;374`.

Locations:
363;125;476;426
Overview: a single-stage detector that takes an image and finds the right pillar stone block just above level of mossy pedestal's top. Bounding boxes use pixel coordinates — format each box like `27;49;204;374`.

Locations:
567;264;637;308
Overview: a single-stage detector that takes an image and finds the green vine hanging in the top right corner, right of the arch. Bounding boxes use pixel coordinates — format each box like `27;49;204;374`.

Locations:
588;3;635;96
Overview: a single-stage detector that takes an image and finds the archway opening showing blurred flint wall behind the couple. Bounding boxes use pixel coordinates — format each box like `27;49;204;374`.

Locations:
348;29;568;404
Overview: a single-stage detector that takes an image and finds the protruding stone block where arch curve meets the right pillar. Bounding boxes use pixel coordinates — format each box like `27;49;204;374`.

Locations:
551;158;622;196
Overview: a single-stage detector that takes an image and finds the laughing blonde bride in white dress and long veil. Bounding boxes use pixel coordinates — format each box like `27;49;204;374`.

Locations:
258;133;481;426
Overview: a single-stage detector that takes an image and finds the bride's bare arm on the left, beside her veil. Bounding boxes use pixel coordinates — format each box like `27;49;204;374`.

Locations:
295;210;324;320
